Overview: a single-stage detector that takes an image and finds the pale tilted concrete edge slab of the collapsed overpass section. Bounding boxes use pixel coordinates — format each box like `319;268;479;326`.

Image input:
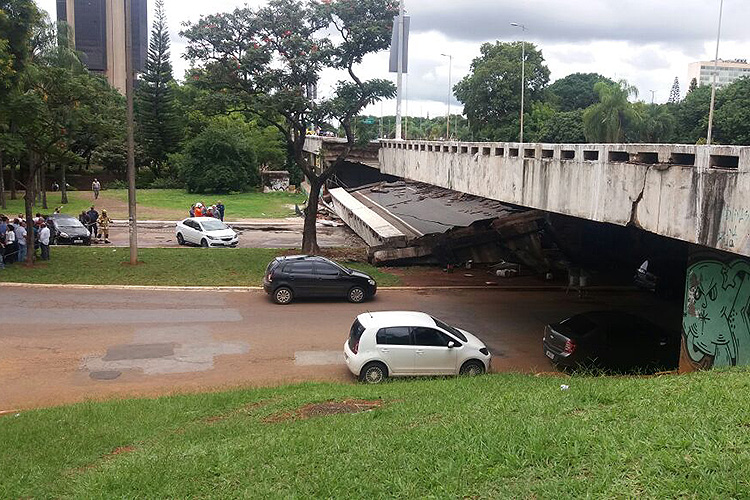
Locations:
330;188;406;247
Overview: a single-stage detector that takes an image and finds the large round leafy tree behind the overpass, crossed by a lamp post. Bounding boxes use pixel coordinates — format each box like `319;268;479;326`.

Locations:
454;42;550;141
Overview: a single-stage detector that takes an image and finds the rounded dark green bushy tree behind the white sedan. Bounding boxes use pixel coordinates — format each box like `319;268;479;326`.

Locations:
177;120;260;194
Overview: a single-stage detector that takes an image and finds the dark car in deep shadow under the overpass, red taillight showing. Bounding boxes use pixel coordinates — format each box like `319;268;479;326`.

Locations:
543;311;680;373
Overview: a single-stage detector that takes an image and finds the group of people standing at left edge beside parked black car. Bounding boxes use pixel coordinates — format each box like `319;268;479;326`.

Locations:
0;214;51;269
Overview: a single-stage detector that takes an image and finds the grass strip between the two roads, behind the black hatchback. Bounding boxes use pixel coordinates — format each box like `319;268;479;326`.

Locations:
0;246;399;286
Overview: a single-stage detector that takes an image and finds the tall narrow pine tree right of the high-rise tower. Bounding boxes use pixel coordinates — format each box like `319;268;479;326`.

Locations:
138;0;182;178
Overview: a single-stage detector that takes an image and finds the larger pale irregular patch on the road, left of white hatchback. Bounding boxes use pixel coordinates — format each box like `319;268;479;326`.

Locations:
81;327;250;380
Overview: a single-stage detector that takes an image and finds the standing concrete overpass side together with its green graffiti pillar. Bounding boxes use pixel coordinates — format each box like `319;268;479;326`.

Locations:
308;140;750;370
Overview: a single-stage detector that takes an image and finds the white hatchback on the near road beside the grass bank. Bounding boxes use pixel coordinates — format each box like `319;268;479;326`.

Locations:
344;311;491;384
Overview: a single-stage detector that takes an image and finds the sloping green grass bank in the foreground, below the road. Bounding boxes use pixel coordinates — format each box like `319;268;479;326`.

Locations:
0;371;750;499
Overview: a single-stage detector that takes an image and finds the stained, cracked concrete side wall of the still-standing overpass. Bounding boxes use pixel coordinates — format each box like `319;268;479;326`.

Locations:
380;140;750;256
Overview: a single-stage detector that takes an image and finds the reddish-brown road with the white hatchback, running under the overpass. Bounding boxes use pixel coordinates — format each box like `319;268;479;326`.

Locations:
0;285;681;411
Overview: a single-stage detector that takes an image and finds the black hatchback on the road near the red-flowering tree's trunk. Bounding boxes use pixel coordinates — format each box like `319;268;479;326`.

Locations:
263;255;378;304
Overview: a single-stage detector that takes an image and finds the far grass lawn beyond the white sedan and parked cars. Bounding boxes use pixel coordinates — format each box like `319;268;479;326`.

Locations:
0;189;306;220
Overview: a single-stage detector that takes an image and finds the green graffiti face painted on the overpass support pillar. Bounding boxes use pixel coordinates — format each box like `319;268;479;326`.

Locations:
682;260;750;368
